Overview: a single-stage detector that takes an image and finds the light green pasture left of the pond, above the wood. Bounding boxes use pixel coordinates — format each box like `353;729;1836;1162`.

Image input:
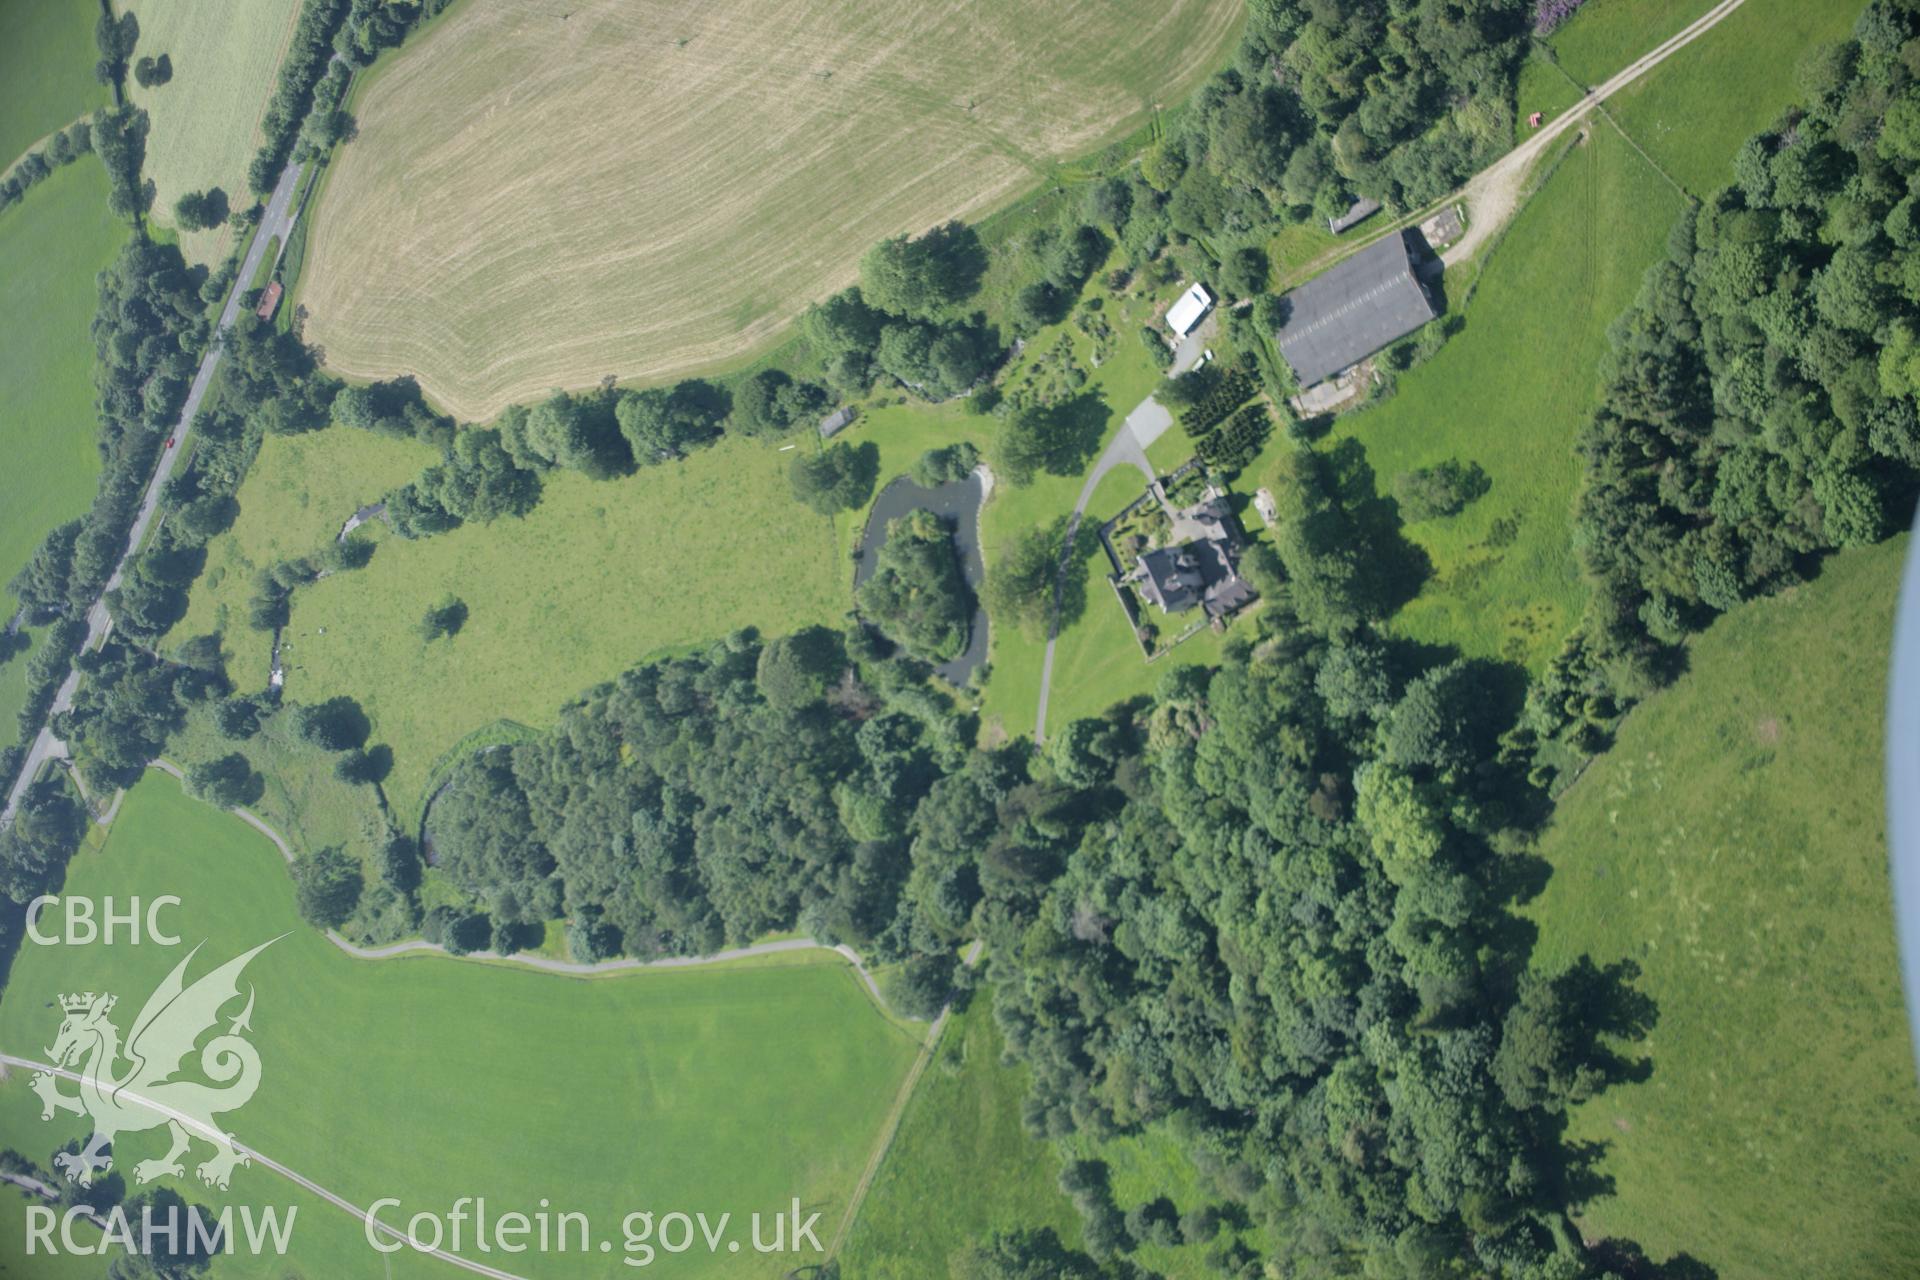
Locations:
276;430;851;818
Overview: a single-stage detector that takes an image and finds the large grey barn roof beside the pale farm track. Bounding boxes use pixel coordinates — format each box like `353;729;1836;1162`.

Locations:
1275;232;1438;388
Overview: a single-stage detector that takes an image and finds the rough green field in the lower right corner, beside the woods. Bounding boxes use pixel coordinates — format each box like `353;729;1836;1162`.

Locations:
1528;537;1920;1280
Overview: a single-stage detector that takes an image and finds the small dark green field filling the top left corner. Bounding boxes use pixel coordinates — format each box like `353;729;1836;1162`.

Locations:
0;0;108;173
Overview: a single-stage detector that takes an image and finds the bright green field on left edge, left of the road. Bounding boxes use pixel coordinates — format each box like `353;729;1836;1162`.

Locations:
0;159;127;616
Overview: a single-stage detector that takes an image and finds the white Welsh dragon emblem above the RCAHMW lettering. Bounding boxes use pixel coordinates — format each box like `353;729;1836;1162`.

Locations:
33;935;284;1190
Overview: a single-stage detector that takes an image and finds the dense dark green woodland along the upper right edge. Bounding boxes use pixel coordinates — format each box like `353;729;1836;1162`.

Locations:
1526;0;1920;782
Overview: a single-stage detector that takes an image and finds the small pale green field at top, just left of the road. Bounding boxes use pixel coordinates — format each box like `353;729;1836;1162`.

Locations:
115;0;300;263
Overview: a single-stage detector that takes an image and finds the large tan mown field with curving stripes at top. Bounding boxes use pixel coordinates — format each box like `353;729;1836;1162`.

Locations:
300;0;1242;418
